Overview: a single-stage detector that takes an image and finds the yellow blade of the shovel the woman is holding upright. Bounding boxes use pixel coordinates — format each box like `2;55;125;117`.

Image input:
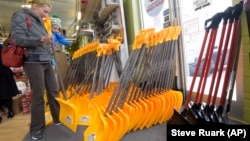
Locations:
56;98;79;132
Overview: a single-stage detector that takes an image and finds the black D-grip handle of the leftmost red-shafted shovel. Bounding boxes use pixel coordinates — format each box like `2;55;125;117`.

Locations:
205;12;224;32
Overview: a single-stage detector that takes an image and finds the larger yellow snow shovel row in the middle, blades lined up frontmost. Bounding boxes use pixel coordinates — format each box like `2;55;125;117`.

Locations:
84;26;183;141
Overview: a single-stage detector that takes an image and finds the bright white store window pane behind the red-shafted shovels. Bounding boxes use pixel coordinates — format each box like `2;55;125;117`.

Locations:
180;0;232;97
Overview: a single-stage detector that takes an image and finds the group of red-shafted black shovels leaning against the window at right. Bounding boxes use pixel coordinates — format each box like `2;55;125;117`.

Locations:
168;1;243;125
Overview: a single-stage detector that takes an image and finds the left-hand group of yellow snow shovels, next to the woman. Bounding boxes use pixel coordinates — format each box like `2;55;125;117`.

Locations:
56;39;122;132
